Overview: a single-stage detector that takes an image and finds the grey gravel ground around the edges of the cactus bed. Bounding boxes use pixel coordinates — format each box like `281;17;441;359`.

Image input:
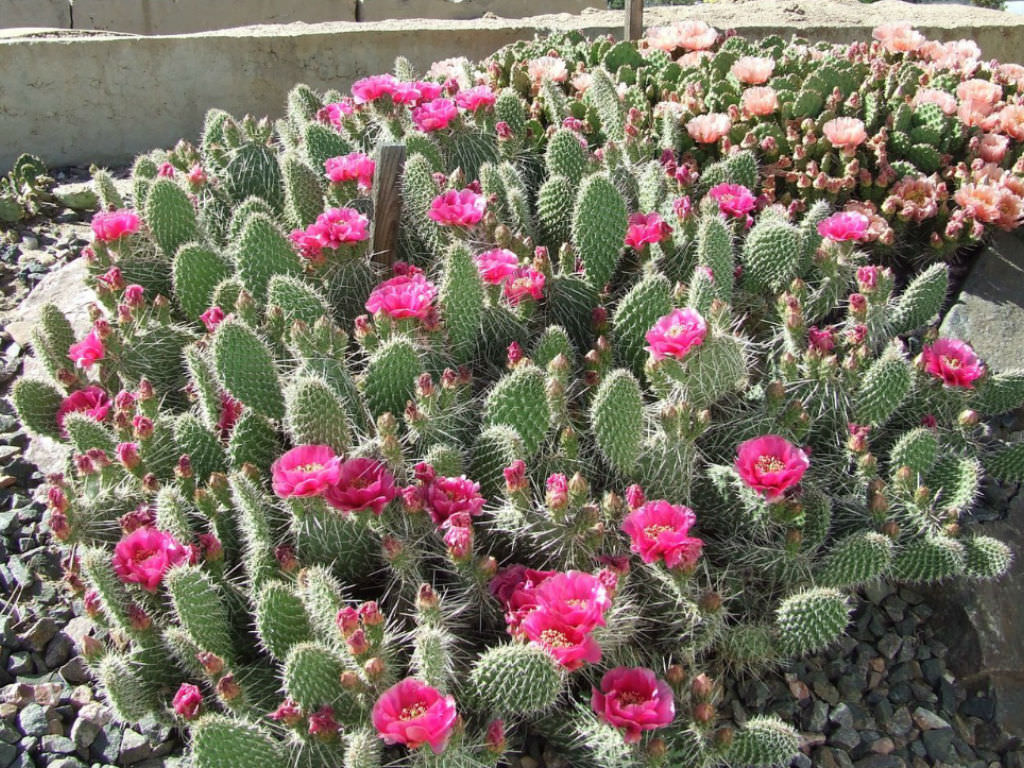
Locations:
0;169;1024;768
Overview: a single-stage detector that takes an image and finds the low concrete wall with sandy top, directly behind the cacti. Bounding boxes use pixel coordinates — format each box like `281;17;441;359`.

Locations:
0;0;1024;171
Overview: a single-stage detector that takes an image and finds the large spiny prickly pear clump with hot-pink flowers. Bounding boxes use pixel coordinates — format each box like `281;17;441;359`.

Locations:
13;22;1024;768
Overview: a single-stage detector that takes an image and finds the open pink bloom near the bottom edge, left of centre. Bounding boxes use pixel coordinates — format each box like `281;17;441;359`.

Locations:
371;678;459;755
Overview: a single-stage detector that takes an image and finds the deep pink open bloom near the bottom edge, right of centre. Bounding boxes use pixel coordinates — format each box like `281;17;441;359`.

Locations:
590;667;676;743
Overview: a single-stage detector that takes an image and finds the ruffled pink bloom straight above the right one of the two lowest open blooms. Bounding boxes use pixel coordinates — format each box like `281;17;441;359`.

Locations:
622;499;703;570
